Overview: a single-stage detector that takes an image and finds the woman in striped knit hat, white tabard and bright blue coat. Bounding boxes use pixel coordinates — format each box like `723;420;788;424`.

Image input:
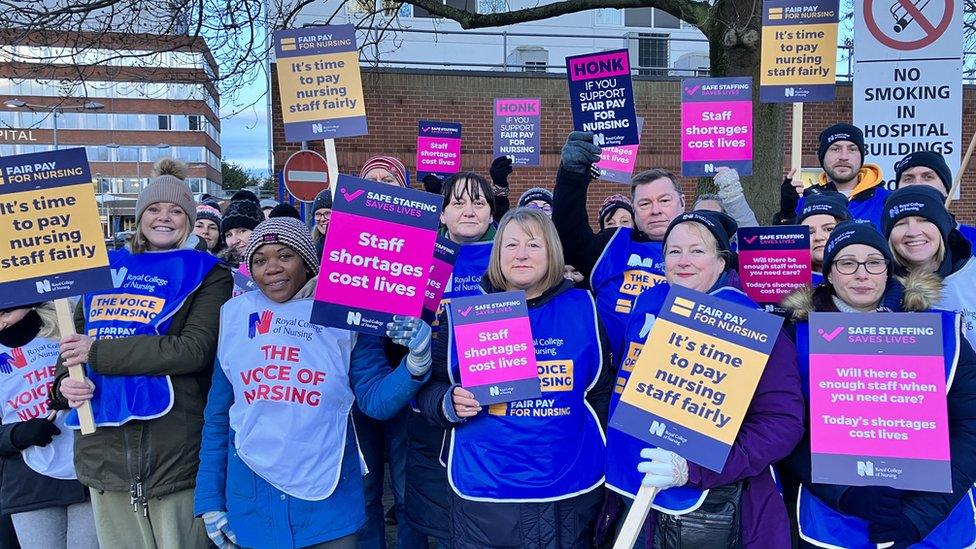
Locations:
195;217;430;549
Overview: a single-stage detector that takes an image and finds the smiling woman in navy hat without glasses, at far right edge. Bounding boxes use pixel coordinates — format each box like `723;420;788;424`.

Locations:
882;185;976;345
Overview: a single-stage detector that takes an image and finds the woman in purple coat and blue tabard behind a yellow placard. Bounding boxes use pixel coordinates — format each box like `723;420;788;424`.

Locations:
607;211;803;548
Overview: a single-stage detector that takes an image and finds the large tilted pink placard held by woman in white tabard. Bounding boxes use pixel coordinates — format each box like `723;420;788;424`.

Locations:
311;175;441;335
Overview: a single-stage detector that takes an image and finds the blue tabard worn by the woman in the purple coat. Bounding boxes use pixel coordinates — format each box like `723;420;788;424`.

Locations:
607;282;759;515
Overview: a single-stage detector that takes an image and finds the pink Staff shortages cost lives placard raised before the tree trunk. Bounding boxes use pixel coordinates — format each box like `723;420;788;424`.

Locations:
681;78;752;176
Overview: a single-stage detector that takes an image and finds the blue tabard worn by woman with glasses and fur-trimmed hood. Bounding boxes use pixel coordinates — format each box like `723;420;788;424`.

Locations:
796;311;976;549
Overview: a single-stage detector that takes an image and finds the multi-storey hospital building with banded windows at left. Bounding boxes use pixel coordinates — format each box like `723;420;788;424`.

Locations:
0;30;221;235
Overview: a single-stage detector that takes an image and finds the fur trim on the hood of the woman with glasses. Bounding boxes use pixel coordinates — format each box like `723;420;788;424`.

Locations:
781;272;945;321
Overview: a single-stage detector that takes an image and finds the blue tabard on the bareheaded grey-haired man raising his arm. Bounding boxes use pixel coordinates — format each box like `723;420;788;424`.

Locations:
590;227;664;363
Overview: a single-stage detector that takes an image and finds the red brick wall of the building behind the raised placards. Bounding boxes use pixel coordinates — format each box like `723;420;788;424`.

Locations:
272;69;976;226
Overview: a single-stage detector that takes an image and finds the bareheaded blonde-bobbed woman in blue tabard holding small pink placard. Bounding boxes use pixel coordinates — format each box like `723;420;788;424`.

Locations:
417;208;613;549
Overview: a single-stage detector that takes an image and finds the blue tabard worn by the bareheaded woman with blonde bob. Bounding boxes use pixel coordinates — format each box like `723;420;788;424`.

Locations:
447;290;609;503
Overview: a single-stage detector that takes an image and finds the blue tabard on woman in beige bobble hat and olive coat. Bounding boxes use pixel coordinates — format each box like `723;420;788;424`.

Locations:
67;249;219;429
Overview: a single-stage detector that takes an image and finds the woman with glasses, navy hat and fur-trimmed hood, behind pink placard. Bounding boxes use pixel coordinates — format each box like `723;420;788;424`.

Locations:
778;219;976;549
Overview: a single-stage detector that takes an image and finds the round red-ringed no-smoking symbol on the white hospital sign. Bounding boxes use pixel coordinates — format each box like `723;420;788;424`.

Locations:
863;0;955;51
